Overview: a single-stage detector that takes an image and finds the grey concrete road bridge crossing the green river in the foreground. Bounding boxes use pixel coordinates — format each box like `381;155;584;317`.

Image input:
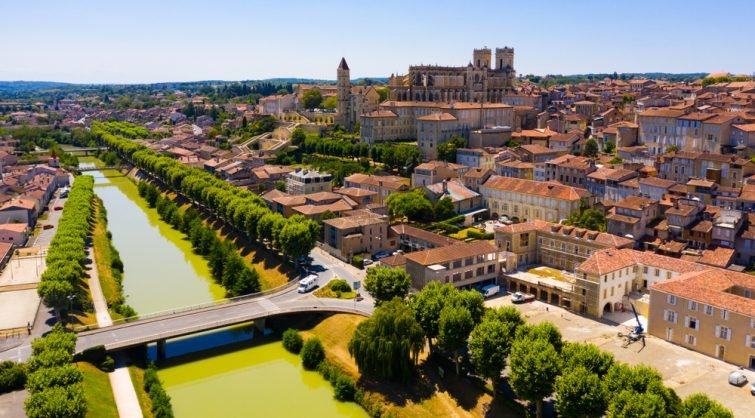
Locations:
0;288;374;361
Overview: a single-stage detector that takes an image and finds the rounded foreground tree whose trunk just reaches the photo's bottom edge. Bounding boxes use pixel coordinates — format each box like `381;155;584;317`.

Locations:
509;338;560;418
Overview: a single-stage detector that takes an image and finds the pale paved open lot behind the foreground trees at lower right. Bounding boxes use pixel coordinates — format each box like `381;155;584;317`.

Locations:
486;295;755;417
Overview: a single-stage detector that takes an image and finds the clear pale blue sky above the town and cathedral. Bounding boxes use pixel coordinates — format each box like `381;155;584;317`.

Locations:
0;0;755;83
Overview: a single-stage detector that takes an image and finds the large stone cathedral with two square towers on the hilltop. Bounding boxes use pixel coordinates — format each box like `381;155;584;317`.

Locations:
386;47;516;103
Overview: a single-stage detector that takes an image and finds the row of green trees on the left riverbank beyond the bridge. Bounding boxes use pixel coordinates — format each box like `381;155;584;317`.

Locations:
37;176;94;312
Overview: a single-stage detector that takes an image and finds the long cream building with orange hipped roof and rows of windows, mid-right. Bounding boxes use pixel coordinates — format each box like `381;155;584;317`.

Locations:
480;176;592;222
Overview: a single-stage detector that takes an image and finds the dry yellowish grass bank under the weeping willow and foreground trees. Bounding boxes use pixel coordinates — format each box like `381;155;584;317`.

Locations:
301;314;524;418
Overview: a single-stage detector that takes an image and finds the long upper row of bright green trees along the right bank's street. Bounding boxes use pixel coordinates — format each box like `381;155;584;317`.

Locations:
92;123;320;259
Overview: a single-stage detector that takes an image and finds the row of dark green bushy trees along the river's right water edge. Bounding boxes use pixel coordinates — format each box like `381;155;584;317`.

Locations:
138;181;261;296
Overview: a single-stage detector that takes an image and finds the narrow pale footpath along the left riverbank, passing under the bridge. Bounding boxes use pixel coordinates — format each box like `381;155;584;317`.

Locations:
87;247;142;418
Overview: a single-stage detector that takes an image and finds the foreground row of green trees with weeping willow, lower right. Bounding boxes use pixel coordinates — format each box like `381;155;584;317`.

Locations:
349;268;733;418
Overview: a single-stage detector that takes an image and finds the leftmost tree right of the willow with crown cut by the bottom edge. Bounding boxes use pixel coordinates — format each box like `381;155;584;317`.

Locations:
554;367;608;418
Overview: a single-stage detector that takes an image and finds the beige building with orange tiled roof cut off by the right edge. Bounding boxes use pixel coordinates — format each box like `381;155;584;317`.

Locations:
648;269;755;369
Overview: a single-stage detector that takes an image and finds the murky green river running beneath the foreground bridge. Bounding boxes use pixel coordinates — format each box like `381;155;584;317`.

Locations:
80;162;367;418
